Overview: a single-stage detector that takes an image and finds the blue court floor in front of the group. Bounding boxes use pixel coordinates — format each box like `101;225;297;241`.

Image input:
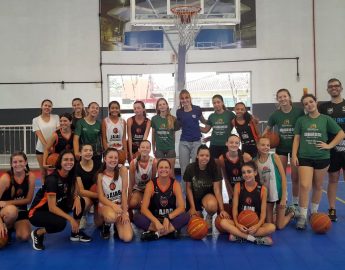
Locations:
0;174;345;270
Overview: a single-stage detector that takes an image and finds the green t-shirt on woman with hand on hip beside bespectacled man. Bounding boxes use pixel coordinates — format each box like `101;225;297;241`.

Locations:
295;114;341;160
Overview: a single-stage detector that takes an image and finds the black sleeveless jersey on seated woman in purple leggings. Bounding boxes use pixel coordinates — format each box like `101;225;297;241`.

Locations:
149;178;176;218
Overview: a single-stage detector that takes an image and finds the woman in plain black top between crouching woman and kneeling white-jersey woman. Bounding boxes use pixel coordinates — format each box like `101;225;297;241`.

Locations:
75;144;102;229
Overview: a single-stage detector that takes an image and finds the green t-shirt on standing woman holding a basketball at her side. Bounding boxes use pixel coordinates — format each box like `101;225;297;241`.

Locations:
268;107;304;153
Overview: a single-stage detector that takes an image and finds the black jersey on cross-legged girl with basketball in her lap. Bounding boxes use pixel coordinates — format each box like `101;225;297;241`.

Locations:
238;182;262;217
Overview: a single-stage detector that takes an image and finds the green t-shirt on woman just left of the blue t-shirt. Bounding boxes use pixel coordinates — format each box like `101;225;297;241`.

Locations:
151;115;178;151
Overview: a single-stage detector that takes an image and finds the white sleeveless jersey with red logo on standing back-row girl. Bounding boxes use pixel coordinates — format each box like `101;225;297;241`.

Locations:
105;117;125;150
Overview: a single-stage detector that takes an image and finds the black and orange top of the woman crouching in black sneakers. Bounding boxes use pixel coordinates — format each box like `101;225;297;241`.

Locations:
29;171;74;217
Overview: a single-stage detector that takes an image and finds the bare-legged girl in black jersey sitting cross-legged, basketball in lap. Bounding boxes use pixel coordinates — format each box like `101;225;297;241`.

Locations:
220;161;275;246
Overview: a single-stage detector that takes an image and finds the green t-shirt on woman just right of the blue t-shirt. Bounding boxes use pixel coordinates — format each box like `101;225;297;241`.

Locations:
207;111;235;146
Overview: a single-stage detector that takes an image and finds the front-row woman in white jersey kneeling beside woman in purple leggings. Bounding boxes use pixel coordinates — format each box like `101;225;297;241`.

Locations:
97;147;133;242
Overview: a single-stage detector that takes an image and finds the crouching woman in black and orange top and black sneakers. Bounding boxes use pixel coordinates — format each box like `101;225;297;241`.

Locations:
29;150;91;250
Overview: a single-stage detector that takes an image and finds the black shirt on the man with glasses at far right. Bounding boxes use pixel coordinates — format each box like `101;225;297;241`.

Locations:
319;99;345;152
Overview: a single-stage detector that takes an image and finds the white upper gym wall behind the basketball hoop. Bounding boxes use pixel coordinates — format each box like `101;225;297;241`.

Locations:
0;0;345;108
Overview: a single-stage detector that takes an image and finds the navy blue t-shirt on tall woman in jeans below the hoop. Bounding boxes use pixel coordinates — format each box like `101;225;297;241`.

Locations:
176;105;202;142
